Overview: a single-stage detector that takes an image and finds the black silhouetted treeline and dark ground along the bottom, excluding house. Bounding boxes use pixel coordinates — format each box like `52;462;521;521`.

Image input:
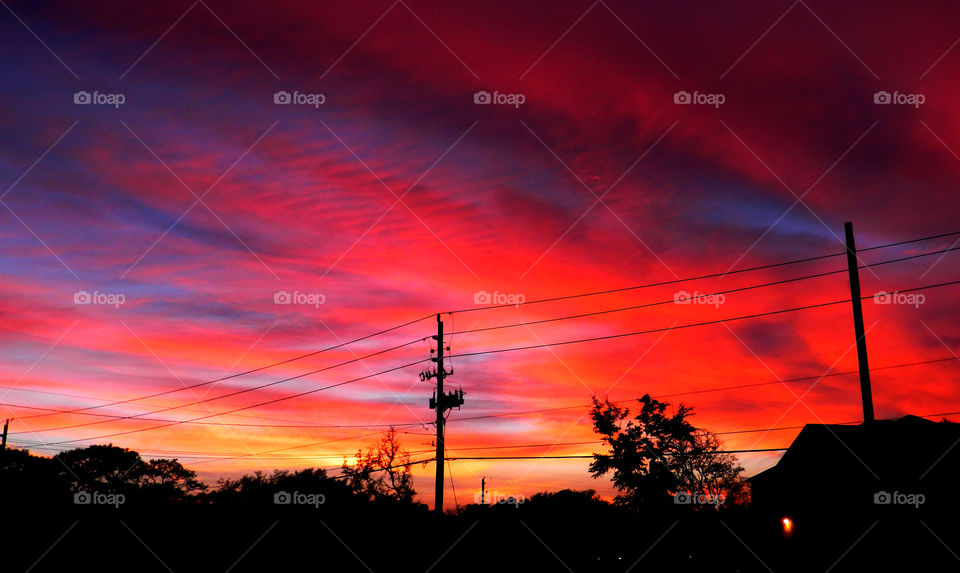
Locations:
0;396;960;572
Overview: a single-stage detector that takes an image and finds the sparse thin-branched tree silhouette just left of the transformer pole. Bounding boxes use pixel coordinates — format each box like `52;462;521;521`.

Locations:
341;426;417;503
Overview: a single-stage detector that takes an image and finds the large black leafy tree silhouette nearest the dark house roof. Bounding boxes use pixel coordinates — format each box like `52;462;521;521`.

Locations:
590;395;746;507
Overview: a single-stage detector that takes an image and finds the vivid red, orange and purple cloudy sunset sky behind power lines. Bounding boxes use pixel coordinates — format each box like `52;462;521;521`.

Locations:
0;0;960;505
